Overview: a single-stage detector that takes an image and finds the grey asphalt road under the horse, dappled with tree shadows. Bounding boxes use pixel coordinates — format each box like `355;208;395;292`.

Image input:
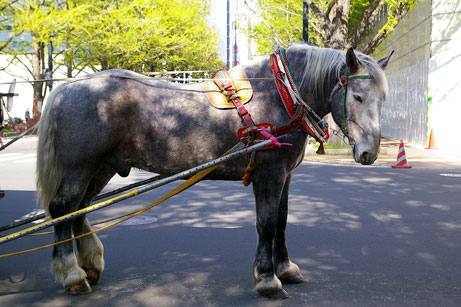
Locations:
0;141;461;307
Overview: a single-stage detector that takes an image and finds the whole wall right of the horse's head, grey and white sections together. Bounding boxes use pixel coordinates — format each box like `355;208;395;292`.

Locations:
382;0;461;155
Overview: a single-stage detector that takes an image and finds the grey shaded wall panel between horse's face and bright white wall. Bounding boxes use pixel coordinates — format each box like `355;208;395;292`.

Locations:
381;1;432;146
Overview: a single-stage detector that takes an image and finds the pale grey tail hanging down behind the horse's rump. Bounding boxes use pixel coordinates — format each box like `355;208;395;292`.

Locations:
36;89;62;215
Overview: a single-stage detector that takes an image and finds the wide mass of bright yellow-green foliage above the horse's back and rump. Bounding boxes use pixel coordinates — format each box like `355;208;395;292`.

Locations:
0;0;222;71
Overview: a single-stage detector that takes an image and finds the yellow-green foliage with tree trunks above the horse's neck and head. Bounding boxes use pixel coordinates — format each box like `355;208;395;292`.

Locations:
249;0;422;54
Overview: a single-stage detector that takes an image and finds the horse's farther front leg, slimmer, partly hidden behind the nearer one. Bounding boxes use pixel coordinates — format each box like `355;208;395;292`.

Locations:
273;174;304;284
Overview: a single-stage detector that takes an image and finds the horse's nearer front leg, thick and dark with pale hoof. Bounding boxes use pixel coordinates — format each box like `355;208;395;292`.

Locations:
252;165;288;299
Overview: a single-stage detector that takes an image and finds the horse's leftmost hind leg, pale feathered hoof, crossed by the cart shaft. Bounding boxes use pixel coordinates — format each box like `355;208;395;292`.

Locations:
49;170;91;294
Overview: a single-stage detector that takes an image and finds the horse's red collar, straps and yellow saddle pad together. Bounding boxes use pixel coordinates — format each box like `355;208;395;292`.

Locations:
202;49;329;186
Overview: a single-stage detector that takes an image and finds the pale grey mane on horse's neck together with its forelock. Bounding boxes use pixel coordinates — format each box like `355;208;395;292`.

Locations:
288;43;388;99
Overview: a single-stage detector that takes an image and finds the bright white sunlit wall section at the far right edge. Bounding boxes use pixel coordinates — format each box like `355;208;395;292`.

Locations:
428;0;461;156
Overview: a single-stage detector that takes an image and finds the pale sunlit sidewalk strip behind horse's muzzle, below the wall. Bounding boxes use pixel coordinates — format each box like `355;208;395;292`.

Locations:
305;137;461;169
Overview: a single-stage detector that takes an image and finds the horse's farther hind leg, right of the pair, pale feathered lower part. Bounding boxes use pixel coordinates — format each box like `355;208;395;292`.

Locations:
72;165;115;285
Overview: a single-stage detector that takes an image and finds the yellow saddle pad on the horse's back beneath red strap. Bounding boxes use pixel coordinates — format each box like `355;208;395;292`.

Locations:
202;66;253;109
